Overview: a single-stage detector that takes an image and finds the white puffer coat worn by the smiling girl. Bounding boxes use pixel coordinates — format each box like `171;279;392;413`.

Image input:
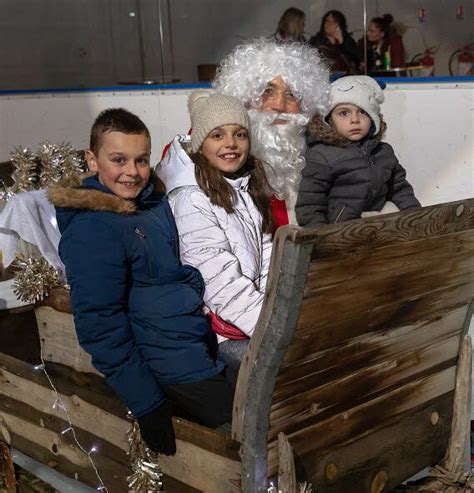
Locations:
157;136;272;342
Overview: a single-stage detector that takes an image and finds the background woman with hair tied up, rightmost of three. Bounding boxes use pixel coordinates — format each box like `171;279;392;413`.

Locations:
359;14;405;74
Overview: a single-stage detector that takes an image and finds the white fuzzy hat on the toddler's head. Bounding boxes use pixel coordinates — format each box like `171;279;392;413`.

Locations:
324;75;385;135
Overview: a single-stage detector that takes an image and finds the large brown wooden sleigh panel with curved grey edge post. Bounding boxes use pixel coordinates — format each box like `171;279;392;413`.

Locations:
233;200;474;493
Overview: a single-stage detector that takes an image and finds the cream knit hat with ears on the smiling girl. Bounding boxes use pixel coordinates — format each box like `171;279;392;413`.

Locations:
188;89;250;152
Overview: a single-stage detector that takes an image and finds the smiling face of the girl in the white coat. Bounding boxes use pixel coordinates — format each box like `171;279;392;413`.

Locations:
201;125;250;173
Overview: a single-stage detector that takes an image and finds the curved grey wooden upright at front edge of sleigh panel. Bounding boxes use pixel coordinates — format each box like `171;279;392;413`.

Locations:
232;226;310;492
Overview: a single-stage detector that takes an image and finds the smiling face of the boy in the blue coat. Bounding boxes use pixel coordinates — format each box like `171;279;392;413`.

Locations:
86;132;151;199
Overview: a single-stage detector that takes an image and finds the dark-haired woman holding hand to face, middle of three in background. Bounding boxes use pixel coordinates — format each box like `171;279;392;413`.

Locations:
309;10;360;74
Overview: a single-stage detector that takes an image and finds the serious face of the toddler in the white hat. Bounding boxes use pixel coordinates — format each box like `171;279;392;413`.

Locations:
330;103;372;142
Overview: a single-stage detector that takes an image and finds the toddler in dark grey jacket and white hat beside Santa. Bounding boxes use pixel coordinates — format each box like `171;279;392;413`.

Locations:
296;75;420;227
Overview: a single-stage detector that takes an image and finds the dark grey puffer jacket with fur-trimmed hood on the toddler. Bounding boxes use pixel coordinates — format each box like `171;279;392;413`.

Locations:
296;117;420;227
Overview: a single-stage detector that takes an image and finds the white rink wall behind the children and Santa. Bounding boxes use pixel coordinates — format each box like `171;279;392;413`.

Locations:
0;80;474;205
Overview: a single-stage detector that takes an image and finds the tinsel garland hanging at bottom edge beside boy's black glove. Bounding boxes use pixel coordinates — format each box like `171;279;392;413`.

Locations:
127;412;163;493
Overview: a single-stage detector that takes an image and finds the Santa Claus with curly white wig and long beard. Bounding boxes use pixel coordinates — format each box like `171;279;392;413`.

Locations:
213;39;329;226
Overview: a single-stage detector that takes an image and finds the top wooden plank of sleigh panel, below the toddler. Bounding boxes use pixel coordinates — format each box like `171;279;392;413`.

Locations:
295;199;474;258
